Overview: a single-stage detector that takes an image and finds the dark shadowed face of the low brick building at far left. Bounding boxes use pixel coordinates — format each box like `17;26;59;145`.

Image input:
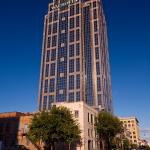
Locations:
0;112;22;150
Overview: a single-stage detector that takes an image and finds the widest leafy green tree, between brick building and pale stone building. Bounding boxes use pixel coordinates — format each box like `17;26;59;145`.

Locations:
29;107;80;150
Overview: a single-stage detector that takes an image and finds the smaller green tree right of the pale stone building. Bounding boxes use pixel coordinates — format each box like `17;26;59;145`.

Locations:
95;112;123;150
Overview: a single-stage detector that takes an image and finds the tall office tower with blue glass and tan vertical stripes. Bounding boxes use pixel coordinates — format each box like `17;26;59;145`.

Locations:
39;0;112;112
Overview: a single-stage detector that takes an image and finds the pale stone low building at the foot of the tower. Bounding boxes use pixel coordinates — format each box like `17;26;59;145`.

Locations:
56;101;98;150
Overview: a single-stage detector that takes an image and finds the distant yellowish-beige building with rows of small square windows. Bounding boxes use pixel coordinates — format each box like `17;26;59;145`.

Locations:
120;117;140;145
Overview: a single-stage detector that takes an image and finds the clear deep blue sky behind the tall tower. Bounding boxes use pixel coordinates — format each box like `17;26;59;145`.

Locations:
0;0;150;128
